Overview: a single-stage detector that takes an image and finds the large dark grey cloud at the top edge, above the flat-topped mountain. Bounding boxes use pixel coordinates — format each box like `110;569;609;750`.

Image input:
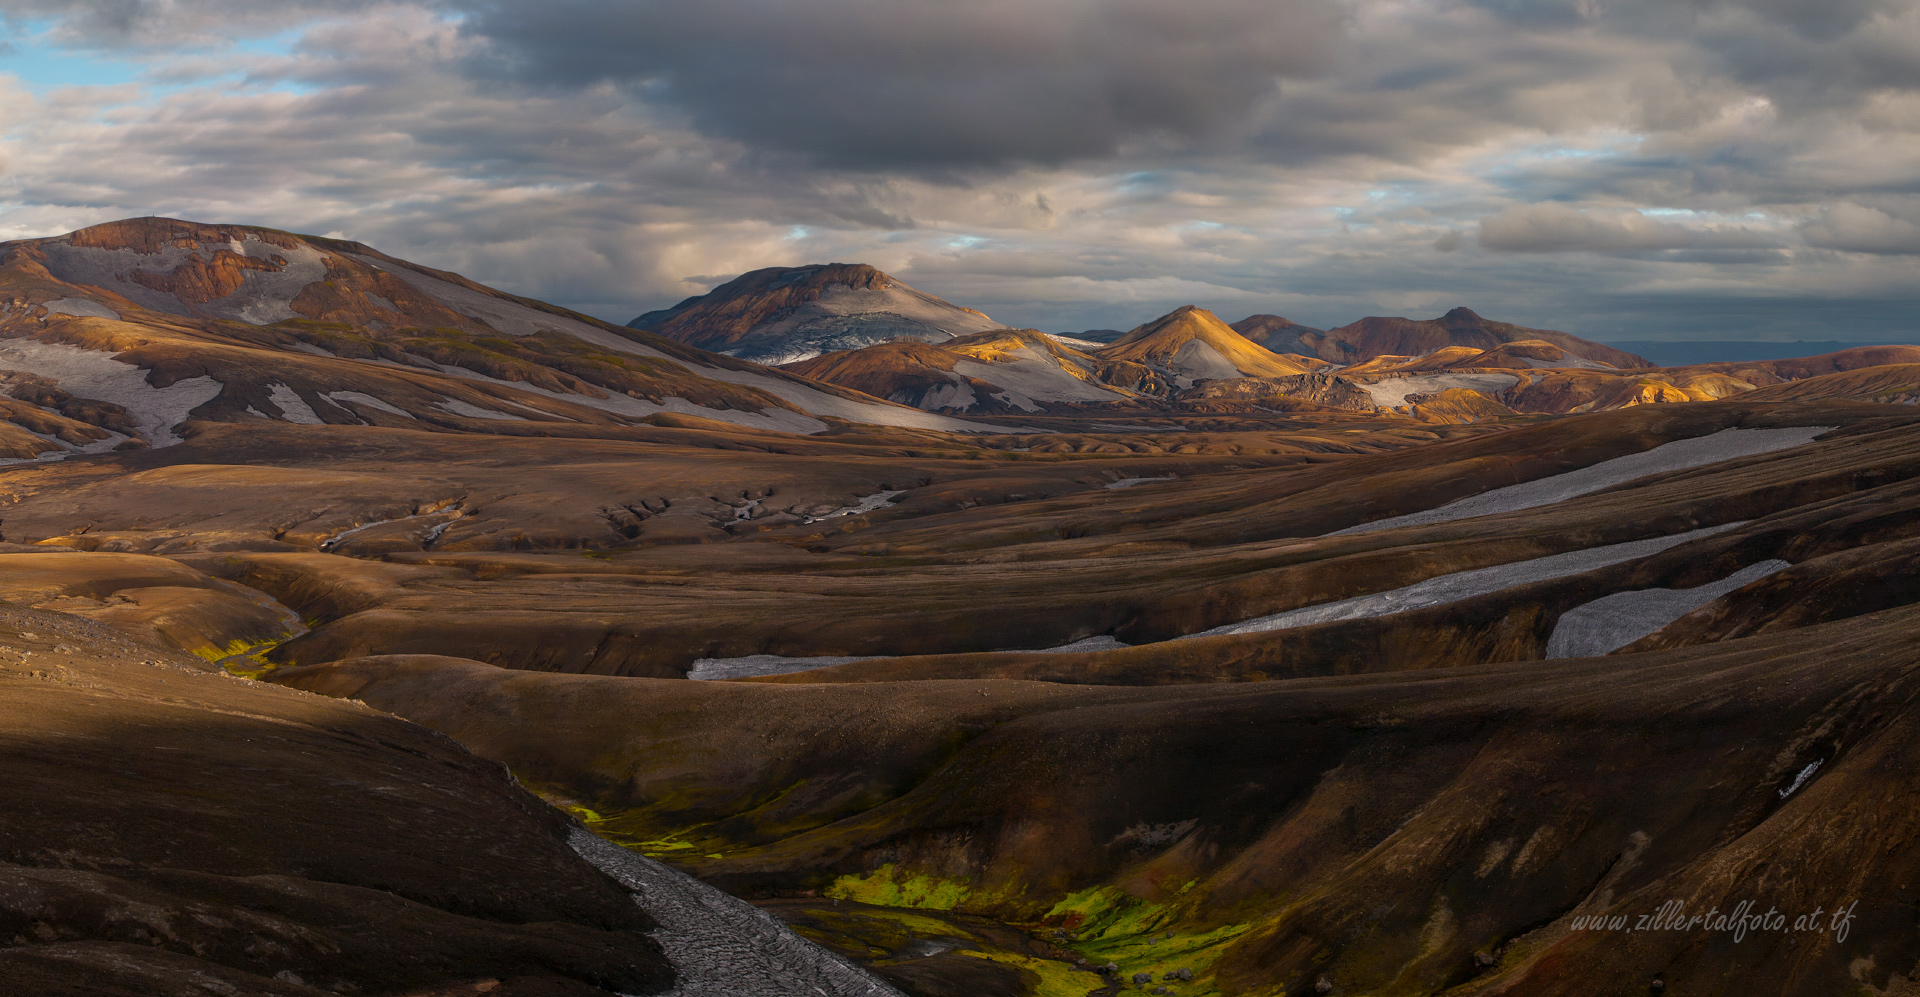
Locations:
453;0;1340;167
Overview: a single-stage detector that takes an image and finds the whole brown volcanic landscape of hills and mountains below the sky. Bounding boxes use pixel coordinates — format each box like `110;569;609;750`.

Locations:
0;219;1920;997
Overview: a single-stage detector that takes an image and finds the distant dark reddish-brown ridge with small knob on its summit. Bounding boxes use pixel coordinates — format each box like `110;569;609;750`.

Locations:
1274;307;1653;369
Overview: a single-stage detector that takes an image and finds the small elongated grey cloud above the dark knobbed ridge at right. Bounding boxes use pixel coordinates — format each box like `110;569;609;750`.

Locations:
1480;204;1772;254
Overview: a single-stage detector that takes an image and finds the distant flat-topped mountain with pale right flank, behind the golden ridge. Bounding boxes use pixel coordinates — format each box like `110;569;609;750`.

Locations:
628;263;1000;363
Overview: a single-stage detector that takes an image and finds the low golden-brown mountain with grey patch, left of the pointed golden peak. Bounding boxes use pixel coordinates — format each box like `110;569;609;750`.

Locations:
785;328;1164;413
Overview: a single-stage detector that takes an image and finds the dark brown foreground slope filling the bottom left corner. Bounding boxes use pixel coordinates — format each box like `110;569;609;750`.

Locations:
0;595;674;997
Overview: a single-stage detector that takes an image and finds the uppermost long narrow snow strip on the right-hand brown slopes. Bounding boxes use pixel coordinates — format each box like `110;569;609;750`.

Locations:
1327;426;1834;536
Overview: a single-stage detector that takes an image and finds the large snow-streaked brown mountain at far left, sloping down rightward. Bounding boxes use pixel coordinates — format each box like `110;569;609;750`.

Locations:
0;217;990;457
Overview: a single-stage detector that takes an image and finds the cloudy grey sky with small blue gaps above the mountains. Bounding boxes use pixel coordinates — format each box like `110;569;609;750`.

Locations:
0;0;1920;342
